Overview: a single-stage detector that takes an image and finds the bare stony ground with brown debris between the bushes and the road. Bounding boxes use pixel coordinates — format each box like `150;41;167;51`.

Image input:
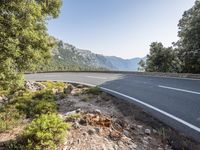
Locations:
0;82;199;150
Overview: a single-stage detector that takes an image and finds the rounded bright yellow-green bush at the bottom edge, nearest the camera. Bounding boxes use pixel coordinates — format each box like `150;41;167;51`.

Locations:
22;114;70;150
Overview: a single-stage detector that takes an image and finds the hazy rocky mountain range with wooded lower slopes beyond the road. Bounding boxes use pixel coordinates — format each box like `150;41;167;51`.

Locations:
40;39;144;71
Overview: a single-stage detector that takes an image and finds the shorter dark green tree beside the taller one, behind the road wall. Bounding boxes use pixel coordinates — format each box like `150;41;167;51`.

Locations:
145;42;176;72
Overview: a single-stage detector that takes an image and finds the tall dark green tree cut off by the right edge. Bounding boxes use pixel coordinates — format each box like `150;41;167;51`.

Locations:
177;0;200;73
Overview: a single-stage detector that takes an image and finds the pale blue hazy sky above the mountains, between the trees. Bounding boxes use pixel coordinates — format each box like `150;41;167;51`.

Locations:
48;0;195;58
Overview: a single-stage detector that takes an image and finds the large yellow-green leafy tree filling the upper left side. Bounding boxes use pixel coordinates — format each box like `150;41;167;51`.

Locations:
0;0;62;89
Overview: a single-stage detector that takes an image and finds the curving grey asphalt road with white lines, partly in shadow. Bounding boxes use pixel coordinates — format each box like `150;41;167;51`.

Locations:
26;73;200;142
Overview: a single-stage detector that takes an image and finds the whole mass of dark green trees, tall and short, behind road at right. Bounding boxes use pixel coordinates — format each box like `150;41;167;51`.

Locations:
139;0;200;73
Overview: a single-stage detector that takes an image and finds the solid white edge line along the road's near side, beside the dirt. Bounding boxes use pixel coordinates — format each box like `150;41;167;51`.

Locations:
27;80;200;132
